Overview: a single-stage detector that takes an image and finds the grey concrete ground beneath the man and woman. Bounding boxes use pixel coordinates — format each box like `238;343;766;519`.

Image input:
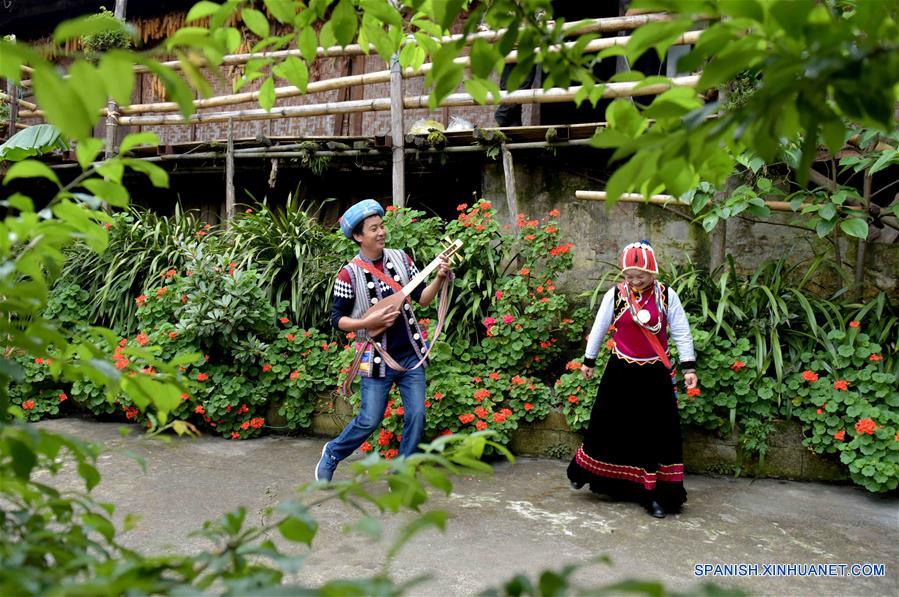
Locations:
31;418;899;596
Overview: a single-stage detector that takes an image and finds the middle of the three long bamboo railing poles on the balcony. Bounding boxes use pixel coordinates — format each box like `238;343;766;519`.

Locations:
119;31;702;114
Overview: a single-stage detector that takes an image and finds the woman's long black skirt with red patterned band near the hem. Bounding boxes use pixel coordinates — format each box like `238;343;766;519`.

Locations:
568;354;687;512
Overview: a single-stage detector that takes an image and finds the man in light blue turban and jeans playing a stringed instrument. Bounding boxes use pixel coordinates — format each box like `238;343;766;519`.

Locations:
315;199;450;481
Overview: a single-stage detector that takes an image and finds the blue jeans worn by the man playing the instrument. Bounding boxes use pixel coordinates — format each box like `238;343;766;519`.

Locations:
326;354;425;461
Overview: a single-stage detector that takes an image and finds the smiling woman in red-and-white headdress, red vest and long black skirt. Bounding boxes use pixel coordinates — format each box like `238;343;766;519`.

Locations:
568;241;698;518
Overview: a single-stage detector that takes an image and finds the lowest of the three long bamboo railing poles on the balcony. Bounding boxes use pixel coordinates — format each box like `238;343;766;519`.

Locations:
119;75;699;126
